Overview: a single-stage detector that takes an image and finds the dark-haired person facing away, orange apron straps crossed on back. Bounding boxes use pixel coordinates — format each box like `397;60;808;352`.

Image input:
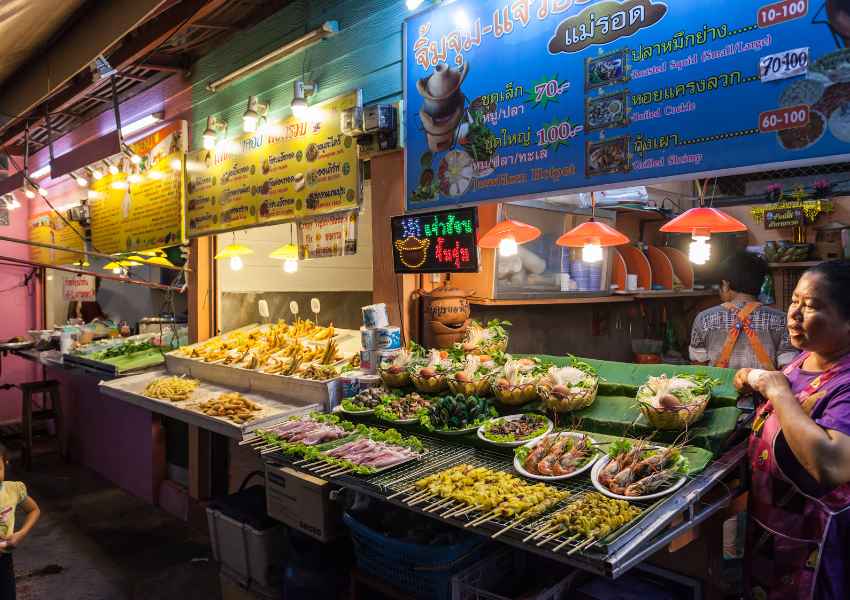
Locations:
689;252;797;371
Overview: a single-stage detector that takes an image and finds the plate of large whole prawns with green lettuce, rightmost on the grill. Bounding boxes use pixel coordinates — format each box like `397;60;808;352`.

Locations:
591;439;689;500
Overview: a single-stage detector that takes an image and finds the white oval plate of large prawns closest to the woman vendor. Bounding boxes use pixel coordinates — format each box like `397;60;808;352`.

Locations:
590;445;688;501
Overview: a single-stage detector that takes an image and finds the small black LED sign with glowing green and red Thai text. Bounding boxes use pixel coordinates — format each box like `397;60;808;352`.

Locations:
391;208;478;273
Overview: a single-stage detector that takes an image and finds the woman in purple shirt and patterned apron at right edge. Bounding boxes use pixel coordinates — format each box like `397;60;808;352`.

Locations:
735;261;850;600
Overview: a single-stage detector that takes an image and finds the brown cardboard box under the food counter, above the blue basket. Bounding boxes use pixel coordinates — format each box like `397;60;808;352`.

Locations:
266;463;342;542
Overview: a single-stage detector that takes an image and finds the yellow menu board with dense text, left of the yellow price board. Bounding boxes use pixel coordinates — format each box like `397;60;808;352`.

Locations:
89;122;186;254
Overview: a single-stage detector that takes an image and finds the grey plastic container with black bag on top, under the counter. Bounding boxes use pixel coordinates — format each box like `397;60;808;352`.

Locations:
207;476;286;587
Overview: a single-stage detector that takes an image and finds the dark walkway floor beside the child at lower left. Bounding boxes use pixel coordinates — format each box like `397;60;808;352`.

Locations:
7;457;220;600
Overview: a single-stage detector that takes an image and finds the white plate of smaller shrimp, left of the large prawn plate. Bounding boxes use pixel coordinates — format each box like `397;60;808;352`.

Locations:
514;431;600;481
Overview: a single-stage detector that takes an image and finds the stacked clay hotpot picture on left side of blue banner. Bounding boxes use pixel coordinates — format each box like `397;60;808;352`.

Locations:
416;63;469;152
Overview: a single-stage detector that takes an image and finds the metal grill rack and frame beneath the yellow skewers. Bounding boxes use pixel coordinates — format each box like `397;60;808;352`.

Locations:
258;433;746;577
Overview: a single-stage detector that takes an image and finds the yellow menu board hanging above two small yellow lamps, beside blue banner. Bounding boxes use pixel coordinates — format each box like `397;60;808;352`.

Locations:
186;92;360;237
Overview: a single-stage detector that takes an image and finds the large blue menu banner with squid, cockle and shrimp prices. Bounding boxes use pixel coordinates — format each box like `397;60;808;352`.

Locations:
405;0;850;210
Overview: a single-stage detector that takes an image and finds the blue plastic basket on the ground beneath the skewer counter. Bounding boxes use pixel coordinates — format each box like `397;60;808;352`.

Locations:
343;513;486;600
